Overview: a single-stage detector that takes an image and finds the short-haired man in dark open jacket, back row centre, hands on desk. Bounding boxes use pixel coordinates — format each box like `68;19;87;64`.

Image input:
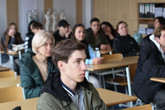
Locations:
85;18;111;50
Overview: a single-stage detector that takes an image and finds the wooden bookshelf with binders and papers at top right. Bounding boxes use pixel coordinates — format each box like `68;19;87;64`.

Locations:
138;2;165;36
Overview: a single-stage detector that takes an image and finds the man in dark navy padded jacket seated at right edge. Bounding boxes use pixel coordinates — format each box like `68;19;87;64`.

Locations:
132;26;165;110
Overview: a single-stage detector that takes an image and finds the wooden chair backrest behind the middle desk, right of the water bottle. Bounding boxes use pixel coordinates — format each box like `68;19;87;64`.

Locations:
102;53;123;63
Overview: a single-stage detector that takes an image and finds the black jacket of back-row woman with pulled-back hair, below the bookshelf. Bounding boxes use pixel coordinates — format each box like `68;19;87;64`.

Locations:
113;35;140;57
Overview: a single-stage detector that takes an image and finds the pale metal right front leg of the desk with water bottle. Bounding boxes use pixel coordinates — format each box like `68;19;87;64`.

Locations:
126;67;133;107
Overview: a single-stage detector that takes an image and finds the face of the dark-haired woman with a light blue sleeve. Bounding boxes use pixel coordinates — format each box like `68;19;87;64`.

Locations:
75;26;85;41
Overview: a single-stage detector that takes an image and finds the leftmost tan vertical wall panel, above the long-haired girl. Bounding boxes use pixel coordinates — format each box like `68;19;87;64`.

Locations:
6;0;19;29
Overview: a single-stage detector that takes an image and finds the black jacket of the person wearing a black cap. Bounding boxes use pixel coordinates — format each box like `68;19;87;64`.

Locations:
53;30;71;45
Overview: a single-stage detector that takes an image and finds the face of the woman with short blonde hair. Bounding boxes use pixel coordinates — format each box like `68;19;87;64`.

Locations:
37;39;53;57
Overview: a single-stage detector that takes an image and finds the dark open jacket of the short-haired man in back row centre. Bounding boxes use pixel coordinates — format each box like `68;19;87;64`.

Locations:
85;28;110;49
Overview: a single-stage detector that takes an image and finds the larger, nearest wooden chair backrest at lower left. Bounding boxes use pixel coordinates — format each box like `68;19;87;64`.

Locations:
0;86;23;103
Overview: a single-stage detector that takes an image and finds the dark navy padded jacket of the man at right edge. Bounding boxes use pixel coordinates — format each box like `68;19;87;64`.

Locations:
132;37;165;103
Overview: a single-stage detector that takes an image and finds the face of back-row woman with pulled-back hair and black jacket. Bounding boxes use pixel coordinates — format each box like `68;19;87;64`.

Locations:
117;23;128;36
